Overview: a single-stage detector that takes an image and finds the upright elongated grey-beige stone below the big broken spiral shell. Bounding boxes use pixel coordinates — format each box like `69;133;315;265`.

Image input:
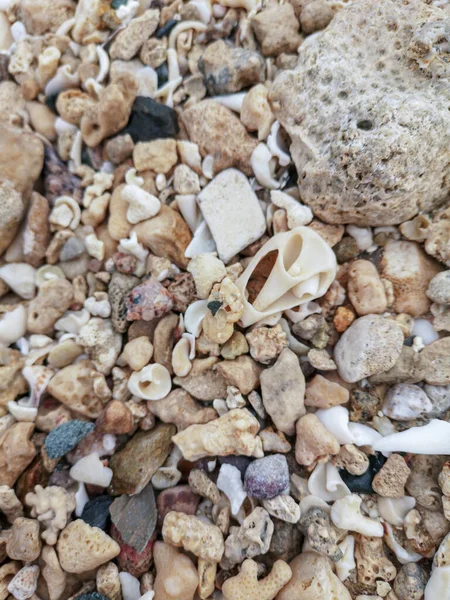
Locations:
261;348;306;435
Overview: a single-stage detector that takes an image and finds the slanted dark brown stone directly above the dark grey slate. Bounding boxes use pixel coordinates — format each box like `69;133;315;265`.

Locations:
109;424;176;495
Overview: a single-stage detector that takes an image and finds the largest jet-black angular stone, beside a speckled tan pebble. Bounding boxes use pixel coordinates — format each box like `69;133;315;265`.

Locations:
121;96;180;144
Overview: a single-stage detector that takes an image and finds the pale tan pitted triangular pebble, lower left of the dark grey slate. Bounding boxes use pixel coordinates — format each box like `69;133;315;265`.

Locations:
57;519;120;573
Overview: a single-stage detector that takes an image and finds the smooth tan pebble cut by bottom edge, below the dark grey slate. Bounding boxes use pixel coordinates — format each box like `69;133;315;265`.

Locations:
153;540;198;600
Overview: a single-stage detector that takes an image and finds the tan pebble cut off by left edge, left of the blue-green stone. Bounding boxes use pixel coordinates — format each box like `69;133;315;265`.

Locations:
0;422;36;487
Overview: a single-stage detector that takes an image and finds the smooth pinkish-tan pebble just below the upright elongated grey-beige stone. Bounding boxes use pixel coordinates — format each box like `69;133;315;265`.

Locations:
295;414;340;466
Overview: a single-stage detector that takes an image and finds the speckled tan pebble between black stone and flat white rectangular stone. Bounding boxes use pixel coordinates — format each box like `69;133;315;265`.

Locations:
181;100;258;175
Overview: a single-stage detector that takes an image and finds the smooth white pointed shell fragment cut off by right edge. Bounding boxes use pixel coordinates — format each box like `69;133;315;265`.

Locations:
373;419;450;454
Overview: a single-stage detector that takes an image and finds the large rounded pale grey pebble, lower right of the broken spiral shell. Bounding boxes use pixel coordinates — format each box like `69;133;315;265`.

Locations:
334;315;404;382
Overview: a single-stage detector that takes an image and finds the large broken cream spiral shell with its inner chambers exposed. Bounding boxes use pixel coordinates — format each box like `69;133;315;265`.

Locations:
236;227;337;327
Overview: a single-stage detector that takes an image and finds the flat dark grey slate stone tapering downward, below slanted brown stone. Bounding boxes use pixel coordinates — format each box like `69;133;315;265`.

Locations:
109;483;158;553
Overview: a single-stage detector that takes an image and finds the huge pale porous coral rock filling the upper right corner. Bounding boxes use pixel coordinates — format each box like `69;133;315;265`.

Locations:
271;0;450;225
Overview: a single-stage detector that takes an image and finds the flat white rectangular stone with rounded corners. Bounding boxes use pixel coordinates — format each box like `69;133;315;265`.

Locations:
198;169;266;264
